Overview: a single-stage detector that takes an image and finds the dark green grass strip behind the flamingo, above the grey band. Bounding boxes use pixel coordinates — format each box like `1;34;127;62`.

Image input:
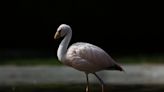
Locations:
0;54;164;66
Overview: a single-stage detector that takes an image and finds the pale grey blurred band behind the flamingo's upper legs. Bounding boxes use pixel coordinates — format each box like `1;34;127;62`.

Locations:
0;64;164;85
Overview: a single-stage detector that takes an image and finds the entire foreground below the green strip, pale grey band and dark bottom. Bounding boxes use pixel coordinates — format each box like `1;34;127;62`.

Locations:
0;65;164;92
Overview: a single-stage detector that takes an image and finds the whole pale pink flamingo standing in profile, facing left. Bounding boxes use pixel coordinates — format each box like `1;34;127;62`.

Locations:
54;24;124;92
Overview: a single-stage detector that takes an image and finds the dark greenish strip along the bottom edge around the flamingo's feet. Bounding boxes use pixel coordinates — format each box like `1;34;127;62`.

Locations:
0;84;164;92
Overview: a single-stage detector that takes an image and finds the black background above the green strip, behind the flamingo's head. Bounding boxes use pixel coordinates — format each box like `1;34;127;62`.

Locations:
0;0;164;58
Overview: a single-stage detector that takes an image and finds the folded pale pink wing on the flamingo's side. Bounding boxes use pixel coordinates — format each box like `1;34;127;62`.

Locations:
65;42;116;72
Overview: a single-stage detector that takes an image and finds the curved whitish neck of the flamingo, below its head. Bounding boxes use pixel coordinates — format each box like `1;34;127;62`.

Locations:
57;30;72;62
